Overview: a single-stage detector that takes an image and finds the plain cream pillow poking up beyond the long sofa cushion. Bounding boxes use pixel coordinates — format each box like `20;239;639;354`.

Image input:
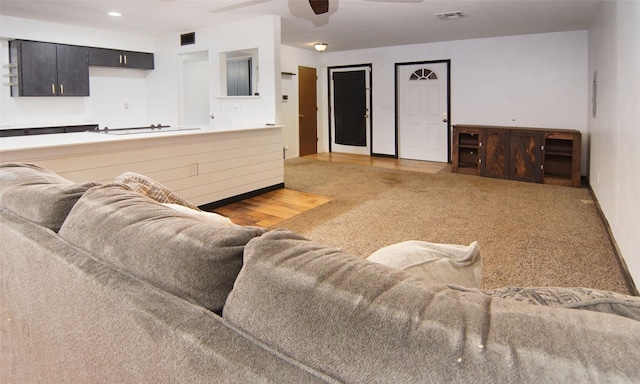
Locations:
367;240;482;288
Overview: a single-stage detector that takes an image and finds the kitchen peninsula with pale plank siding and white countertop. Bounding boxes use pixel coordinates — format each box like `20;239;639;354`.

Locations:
0;125;284;206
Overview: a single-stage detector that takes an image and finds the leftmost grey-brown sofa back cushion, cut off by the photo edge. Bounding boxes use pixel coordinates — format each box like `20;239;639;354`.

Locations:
0;163;98;231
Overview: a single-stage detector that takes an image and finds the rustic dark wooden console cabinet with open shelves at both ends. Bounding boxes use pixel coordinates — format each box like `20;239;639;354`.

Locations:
452;125;582;188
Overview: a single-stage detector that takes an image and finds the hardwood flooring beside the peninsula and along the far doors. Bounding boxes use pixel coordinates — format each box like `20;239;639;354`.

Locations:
214;152;449;228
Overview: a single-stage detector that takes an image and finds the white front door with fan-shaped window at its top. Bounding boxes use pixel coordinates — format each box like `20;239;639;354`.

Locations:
397;62;449;162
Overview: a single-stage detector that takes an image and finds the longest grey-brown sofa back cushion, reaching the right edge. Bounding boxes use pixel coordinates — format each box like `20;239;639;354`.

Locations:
223;230;640;383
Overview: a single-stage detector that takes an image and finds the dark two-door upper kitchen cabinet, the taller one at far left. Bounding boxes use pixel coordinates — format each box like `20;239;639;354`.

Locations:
9;40;89;96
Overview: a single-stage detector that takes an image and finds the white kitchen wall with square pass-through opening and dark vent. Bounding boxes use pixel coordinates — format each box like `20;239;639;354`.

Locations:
147;16;280;128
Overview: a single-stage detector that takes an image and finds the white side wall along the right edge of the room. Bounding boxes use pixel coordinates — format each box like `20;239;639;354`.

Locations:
587;1;640;286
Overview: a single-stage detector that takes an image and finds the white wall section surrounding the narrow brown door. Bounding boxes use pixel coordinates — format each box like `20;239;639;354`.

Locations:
280;45;327;158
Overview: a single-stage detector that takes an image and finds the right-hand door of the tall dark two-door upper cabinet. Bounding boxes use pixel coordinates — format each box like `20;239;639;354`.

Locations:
57;45;89;96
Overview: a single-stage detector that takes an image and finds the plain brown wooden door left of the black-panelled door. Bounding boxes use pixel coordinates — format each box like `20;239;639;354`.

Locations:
298;67;318;156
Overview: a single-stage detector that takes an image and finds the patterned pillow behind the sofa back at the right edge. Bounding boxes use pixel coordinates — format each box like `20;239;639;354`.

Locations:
484;287;640;321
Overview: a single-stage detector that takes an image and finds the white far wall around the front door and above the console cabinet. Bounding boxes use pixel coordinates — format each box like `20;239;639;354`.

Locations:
323;31;588;172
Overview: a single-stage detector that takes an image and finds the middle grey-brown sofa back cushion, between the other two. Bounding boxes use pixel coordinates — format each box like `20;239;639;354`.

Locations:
59;184;265;311
